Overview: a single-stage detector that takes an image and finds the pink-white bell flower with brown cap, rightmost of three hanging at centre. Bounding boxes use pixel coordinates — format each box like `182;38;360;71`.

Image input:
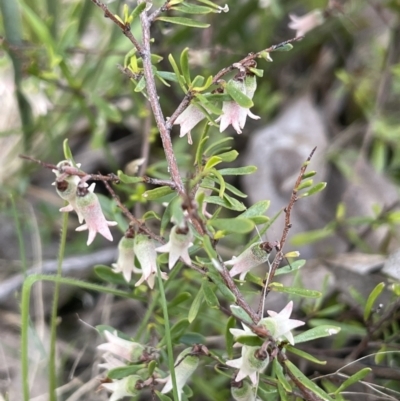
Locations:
156;226;193;270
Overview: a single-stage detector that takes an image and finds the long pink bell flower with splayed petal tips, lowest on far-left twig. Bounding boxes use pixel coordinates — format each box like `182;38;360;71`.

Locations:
76;184;117;245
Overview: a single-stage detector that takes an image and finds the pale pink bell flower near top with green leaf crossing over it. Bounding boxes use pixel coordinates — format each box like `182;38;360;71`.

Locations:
215;75;260;134
